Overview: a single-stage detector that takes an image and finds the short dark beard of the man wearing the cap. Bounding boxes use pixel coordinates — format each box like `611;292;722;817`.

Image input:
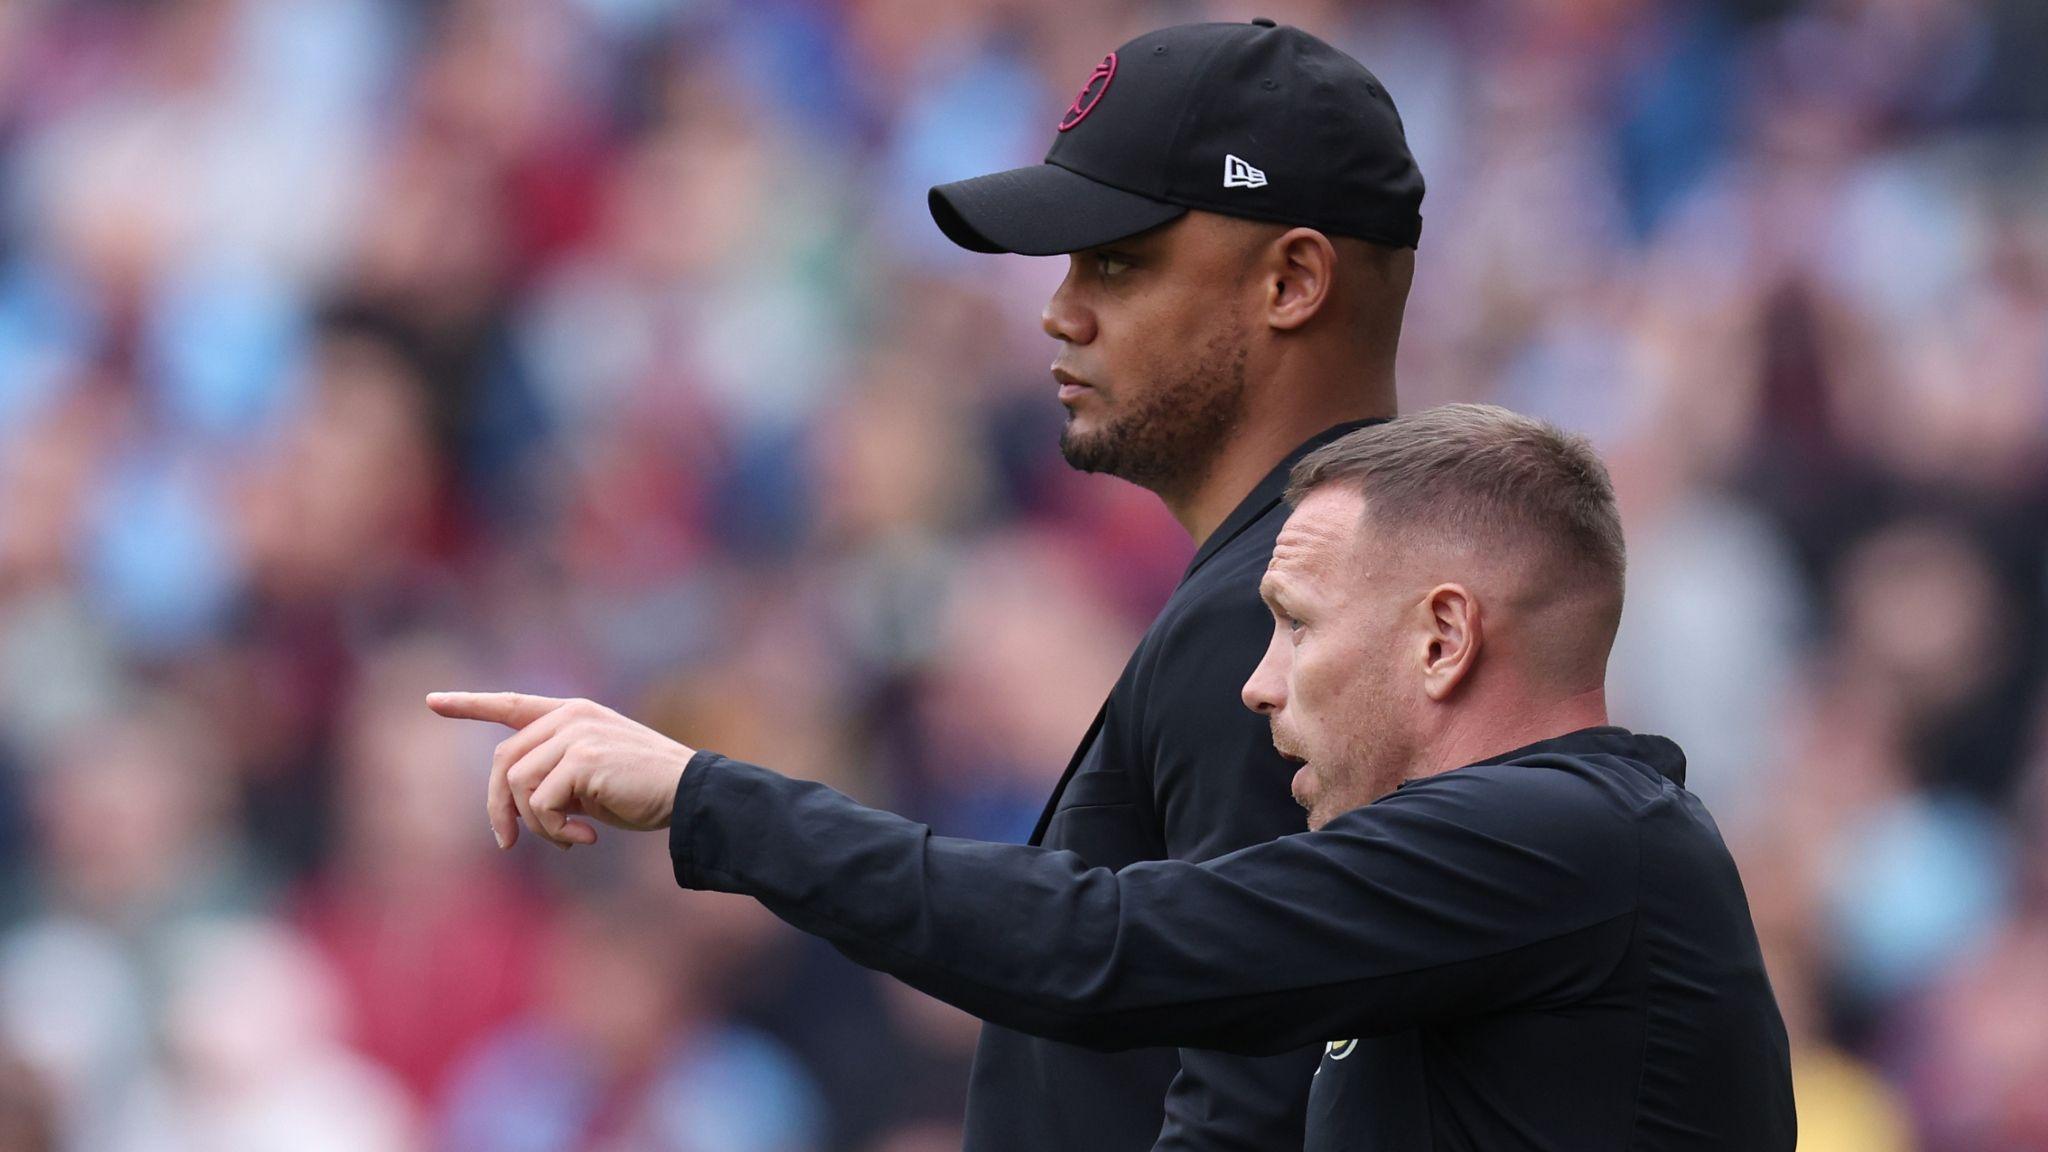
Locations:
1059;332;1249;496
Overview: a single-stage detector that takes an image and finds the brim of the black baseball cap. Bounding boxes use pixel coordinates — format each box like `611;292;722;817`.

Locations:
928;164;1188;256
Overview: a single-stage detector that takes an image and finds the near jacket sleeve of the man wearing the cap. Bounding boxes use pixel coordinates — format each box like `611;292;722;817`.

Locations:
1139;565;1321;1152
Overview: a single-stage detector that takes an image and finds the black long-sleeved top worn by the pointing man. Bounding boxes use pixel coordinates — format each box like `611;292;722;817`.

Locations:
670;728;1794;1152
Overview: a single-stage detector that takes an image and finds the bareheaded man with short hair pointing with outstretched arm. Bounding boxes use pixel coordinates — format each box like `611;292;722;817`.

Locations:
428;406;1794;1152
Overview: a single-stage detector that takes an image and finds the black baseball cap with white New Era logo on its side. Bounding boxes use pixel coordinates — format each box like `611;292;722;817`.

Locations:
930;18;1423;256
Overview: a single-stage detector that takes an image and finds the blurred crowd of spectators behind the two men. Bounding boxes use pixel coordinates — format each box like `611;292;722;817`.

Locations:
0;0;2048;1152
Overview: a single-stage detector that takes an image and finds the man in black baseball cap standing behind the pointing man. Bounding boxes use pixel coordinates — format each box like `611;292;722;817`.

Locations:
930;18;1423;1152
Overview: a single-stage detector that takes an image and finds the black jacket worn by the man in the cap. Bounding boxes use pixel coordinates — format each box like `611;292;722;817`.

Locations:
965;420;1366;1152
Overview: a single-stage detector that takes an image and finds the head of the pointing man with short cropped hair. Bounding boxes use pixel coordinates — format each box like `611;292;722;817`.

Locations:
1243;404;1628;828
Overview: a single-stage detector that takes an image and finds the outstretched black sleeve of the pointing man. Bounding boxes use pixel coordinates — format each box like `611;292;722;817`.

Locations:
670;752;1636;1056
